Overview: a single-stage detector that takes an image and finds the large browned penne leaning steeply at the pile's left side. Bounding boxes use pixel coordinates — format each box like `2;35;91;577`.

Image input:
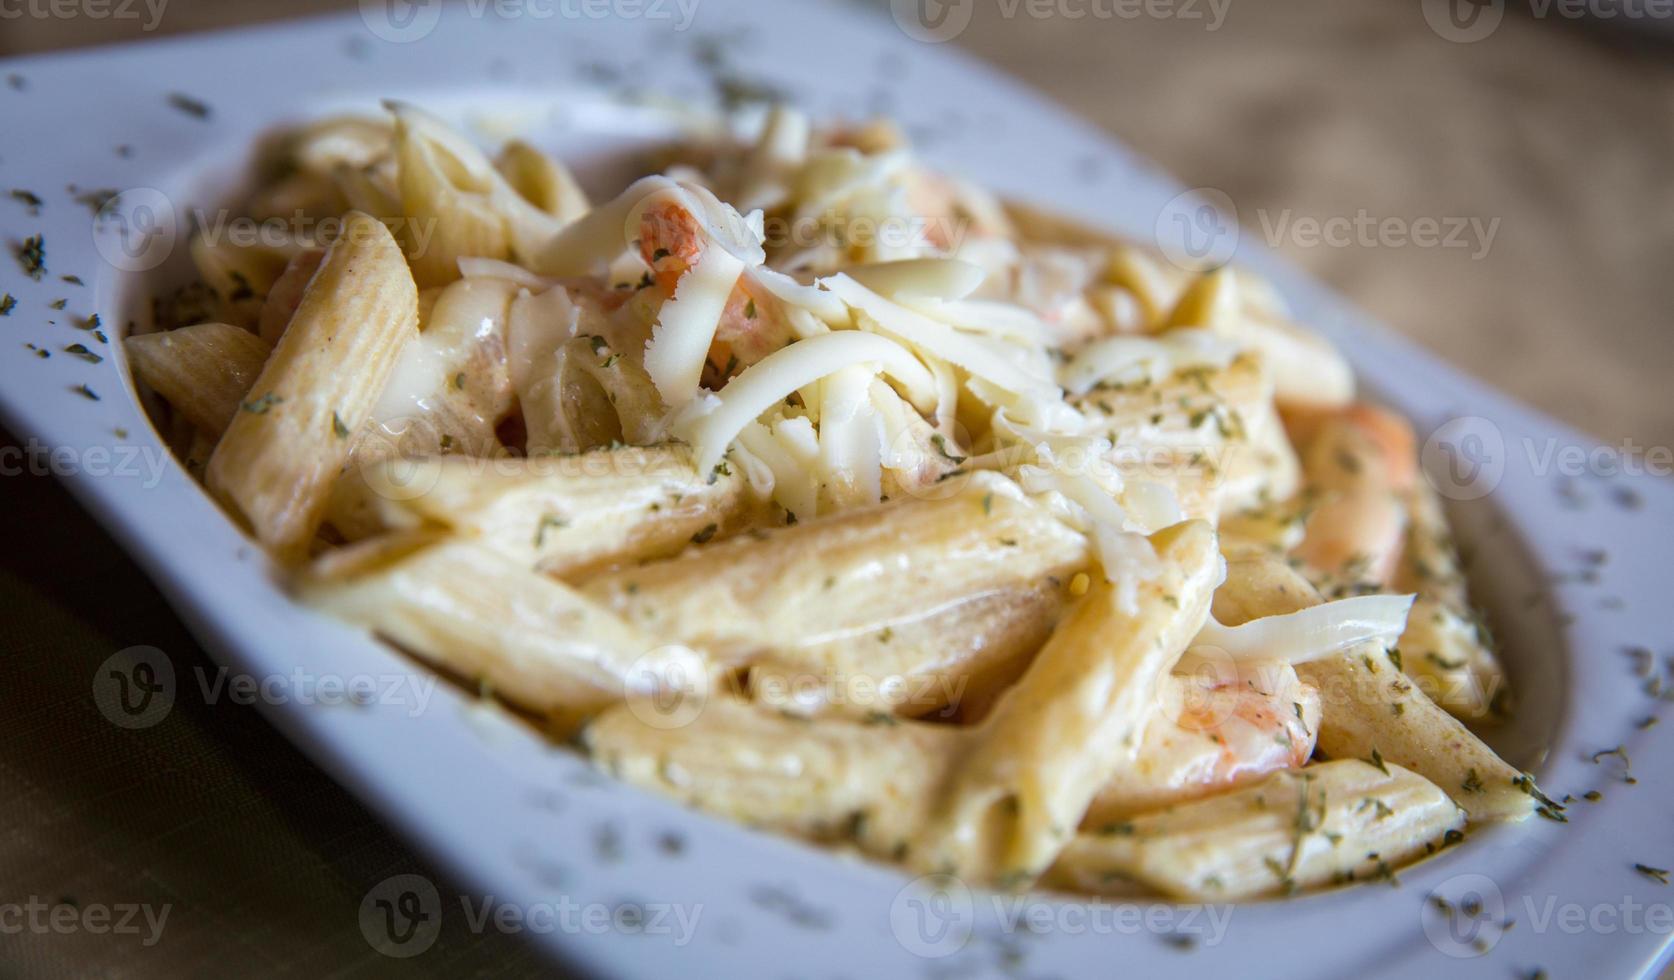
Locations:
206;211;419;563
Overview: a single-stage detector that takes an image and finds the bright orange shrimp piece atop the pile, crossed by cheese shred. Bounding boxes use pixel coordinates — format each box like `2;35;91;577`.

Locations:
639;201;795;387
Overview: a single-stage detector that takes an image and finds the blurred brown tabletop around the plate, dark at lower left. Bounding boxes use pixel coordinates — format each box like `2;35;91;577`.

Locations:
0;0;1674;975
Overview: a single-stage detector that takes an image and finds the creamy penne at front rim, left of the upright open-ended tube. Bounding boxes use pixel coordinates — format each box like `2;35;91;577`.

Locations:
583;699;963;858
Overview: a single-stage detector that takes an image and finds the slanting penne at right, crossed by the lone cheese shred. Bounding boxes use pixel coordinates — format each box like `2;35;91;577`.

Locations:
1214;558;1538;821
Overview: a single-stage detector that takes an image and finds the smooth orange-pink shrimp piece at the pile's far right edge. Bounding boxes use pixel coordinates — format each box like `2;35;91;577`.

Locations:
1296;404;1418;591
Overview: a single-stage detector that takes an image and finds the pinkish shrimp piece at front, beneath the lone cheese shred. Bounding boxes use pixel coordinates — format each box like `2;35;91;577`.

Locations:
1081;660;1319;829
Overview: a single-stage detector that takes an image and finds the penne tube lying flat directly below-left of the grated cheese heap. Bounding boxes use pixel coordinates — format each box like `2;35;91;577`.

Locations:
349;444;755;580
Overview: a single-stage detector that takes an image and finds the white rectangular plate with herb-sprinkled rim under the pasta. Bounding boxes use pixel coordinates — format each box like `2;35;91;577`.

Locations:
0;0;1674;980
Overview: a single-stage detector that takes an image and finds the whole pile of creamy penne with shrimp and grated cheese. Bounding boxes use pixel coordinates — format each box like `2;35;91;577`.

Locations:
126;104;1558;900
